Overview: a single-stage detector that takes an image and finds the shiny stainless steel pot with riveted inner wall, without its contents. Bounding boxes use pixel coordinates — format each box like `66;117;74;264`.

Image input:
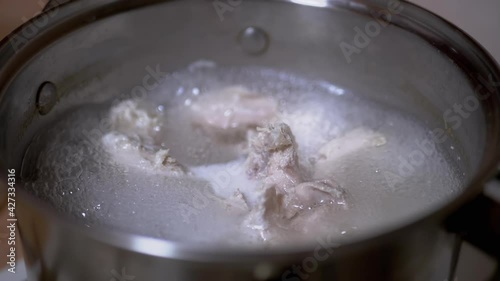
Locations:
0;0;500;281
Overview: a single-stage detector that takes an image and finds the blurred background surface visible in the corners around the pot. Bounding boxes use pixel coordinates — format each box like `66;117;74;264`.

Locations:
0;0;500;281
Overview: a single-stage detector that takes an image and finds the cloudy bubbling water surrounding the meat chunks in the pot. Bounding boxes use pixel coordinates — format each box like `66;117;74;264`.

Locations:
21;63;465;245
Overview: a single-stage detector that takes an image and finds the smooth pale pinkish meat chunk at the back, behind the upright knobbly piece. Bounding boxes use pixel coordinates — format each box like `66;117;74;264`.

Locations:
191;86;278;138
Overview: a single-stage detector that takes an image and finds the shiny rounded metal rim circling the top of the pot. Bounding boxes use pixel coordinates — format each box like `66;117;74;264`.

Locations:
0;0;500;263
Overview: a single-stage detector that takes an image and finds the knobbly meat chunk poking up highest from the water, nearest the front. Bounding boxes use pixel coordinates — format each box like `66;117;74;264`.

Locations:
245;122;349;240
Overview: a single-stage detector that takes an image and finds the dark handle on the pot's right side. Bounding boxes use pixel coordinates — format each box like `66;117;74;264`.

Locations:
446;180;500;261
